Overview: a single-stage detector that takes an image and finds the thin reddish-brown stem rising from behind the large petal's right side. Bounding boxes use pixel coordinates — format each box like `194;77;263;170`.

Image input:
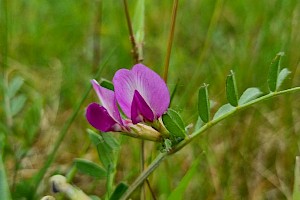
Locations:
163;0;178;82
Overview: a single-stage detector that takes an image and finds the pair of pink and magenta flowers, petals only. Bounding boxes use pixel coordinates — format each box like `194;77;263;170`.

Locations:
86;64;170;132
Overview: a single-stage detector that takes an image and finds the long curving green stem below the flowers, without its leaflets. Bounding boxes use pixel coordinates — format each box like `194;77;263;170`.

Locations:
121;87;300;200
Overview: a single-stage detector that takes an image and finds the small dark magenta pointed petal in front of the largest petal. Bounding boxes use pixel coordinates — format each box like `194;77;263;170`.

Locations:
131;90;154;124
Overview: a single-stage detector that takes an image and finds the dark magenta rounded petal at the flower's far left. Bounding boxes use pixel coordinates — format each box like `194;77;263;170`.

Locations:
86;103;117;132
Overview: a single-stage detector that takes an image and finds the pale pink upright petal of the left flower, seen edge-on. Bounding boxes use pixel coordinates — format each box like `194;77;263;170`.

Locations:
91;80;123;124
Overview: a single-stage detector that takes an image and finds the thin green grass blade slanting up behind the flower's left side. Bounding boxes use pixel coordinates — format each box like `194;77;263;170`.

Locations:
32;50;114;193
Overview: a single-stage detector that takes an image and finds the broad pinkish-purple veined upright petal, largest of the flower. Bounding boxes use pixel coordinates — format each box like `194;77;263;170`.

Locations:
113;64;170;118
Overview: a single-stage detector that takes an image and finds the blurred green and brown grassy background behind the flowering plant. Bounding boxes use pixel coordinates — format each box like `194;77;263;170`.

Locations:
0;0;300;199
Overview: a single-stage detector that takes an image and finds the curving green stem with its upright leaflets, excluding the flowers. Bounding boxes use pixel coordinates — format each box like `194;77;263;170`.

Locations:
121;53;300;200
